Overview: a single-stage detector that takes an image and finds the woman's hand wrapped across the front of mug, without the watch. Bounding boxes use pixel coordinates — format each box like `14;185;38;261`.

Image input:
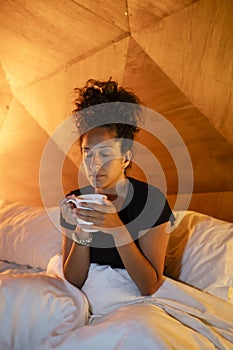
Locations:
73;198;124;234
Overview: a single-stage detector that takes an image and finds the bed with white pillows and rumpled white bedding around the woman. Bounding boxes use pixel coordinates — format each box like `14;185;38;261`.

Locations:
0;199;233;350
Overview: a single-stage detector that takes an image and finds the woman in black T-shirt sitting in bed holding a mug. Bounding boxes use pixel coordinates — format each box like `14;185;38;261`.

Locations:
61;80;174;295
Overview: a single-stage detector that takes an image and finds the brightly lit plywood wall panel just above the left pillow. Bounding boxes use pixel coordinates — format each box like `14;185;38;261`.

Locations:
0;99;77;205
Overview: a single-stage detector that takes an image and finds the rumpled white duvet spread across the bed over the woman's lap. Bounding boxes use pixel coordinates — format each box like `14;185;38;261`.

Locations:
0;255;233;350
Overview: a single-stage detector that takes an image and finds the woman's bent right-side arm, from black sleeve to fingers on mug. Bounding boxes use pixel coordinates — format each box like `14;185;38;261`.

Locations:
76;200;169;295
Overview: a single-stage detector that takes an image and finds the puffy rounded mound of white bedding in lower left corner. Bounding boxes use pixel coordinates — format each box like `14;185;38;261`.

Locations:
0;273;88;349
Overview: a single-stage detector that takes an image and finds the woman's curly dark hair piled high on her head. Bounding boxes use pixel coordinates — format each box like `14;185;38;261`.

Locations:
73;78;142;153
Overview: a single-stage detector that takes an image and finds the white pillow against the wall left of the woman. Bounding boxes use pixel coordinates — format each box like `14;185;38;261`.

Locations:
0;200;62;269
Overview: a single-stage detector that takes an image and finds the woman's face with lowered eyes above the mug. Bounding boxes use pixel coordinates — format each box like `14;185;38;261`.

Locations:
81;128;130;190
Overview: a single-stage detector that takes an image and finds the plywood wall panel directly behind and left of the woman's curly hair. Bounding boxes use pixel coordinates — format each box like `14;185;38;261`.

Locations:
11;37;129;159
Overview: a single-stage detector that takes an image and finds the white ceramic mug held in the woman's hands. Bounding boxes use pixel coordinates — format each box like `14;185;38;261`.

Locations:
66;193;107;232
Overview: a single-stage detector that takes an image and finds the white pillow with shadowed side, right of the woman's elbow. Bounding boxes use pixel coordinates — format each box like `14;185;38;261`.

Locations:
165;211;233;302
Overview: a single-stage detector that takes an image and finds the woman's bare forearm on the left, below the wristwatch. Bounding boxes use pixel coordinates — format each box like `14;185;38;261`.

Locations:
62;230;90;288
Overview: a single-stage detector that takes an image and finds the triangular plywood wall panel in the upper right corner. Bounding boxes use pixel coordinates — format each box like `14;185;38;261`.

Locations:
133;0;233;143
